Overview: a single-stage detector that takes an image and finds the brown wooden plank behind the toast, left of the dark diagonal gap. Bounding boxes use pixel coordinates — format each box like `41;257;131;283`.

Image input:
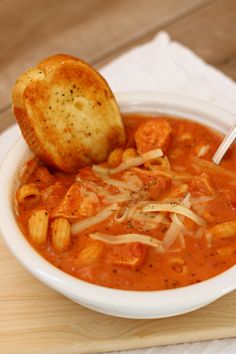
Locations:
0;0;212;109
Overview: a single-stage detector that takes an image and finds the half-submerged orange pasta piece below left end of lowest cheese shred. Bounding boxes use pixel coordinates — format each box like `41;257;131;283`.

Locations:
75;240;104;267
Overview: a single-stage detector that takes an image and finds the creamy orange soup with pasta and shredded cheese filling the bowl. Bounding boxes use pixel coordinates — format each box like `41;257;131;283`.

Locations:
15;115;236;290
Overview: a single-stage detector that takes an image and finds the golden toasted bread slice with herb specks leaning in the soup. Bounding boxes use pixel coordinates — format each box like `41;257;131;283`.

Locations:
12;54;125;172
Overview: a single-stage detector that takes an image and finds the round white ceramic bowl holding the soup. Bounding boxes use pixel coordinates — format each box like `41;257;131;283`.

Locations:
0;92;236;319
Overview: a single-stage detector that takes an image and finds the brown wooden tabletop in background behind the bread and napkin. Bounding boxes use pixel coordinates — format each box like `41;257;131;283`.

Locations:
0;0;236;132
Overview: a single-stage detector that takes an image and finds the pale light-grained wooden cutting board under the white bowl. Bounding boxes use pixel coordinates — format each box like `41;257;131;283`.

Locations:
0;235;236;354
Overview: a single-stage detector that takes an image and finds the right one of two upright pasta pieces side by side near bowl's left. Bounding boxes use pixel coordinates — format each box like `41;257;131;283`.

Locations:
51;218;71;252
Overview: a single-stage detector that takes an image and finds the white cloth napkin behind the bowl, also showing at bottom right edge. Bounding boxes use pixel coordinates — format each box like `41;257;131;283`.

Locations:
101;32;236;354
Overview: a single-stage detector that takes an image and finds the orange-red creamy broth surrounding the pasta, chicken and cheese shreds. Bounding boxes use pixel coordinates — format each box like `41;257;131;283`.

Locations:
17;115;236;290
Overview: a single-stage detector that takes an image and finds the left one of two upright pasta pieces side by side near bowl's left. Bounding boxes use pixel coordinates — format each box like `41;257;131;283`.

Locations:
28;209;49;245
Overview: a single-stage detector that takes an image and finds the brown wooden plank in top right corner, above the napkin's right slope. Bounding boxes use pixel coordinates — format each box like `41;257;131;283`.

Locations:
165;0;236;80
